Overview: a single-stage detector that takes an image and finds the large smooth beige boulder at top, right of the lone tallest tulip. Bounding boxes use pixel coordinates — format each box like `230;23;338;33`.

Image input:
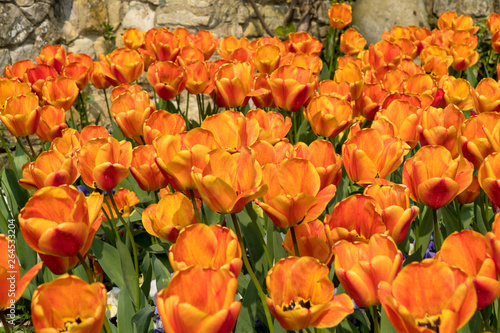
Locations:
352;0;429;44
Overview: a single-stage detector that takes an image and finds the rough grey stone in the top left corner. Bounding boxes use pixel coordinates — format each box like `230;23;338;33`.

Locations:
0;4;34;47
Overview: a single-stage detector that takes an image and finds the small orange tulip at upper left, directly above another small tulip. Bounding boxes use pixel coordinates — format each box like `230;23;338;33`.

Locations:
42;76;79;111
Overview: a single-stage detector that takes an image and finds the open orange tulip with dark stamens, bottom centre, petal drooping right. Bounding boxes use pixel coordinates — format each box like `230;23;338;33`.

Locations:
266;257;354;331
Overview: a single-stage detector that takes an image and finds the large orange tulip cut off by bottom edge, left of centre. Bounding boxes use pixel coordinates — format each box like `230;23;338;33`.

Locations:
156;265;241;333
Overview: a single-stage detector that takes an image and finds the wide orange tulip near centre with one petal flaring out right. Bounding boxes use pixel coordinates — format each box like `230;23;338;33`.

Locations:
258;158;336;228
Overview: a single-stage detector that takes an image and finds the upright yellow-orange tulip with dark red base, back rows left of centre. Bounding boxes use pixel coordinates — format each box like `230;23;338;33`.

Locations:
214;62;252;108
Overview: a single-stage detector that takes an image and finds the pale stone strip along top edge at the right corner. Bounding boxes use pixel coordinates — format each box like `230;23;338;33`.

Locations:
433;0;495;18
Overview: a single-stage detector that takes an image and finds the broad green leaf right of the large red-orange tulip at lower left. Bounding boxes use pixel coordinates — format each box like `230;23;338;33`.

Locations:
90;238;125;289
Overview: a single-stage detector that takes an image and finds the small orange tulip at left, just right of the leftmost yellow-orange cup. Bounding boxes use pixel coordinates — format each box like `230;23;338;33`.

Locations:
36;105;68;142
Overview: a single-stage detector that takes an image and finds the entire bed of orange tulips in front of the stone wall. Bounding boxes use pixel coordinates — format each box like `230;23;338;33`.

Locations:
0;4;500;333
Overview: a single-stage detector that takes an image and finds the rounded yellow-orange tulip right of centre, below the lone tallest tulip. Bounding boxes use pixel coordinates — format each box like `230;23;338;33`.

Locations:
305;95;353;138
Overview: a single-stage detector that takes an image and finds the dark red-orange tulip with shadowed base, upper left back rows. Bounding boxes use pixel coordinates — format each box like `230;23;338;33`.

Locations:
147;61;187;100
